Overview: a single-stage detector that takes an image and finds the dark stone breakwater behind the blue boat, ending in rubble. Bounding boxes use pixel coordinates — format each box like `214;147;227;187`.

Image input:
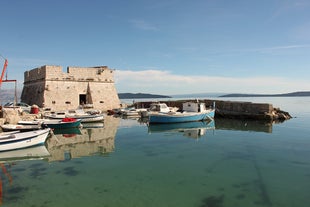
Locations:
134;99;292;121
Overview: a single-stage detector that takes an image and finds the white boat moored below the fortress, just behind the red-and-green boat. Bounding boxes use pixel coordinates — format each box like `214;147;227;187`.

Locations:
45;109;104;123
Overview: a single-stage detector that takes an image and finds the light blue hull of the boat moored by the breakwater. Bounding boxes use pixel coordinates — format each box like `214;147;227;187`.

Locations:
149;110;215;124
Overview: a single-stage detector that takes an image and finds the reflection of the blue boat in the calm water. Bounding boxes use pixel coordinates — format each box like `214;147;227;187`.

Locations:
148;120;215;138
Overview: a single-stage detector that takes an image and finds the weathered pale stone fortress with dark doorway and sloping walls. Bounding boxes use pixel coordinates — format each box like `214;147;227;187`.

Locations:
21;65;120;111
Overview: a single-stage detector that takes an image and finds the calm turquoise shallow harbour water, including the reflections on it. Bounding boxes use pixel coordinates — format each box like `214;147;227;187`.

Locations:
0;98;310;207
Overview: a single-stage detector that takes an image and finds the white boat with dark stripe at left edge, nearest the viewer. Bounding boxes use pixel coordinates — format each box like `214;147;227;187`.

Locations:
0;128;50;152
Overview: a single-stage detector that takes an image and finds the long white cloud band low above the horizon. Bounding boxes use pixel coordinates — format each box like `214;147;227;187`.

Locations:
115;70;310;95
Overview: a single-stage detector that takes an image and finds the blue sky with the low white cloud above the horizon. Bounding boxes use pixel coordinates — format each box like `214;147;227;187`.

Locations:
0;0;310;95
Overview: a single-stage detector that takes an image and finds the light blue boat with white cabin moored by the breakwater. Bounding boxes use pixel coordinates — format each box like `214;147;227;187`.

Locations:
149;102;215;124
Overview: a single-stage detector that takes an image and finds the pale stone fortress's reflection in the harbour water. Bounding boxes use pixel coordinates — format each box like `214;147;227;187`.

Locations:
47;116;120;162
